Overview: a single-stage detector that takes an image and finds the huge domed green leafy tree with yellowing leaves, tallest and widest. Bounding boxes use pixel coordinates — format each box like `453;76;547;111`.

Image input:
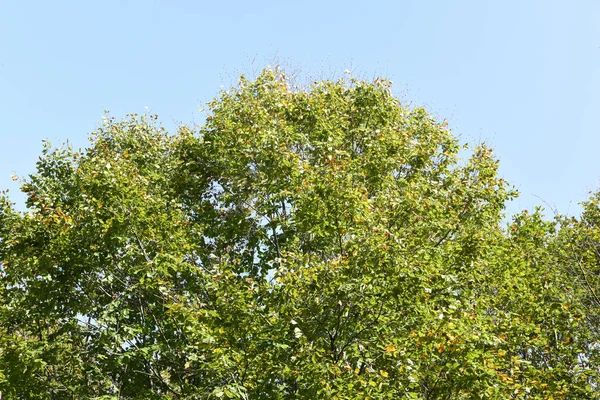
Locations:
0;70;598;399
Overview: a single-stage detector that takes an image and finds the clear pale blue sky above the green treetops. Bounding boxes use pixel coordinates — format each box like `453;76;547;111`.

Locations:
0;0;600;214
